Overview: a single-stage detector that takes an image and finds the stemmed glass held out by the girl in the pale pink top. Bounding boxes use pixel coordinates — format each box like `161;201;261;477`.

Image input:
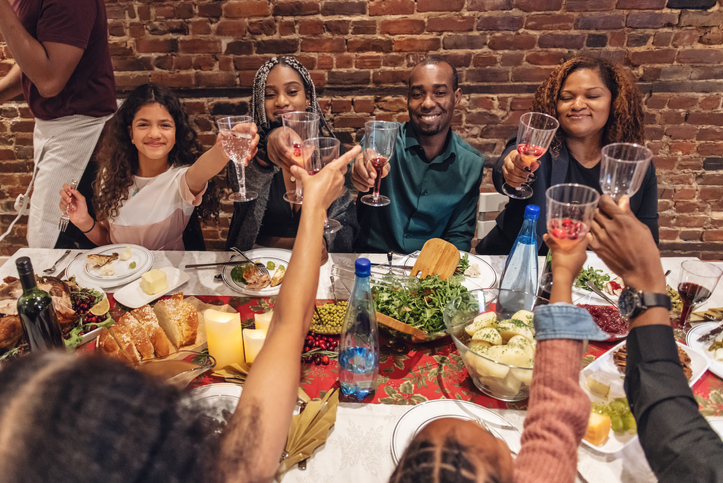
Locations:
216;116;259;202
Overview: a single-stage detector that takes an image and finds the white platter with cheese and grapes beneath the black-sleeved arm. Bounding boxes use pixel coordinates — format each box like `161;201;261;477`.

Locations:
580;341;708;455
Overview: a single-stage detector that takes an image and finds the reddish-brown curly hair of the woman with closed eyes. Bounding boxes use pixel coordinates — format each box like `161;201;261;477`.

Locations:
532;56;645;156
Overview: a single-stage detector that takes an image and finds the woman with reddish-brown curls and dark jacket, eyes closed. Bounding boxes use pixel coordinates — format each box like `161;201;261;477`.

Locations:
476;56;658;255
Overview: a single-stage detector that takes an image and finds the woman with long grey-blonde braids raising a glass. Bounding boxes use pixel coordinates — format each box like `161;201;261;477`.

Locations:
226;56;359;258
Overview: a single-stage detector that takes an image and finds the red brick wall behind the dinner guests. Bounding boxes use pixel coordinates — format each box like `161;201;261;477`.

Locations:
0;0;723;258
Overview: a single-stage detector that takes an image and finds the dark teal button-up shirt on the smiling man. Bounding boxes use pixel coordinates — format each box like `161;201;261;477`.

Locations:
355;122;484;253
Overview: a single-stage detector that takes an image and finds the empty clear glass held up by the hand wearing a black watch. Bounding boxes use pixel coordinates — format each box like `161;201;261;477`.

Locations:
600;143;653;202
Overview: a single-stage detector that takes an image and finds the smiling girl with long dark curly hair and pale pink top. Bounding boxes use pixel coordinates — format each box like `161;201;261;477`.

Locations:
60;84;258;250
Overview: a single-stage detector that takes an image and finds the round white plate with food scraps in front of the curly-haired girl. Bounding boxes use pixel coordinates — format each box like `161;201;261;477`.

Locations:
67;244;153;288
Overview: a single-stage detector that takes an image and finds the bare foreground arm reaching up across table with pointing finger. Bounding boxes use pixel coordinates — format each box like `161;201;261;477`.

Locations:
218;148;358;482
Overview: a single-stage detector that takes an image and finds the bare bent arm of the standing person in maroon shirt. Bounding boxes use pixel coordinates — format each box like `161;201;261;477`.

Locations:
0;0;83;97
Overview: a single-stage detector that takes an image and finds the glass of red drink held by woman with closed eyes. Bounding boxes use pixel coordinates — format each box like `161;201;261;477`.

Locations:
502;112;560;200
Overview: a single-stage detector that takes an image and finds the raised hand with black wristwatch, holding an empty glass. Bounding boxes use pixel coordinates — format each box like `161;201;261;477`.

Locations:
590;195;665;293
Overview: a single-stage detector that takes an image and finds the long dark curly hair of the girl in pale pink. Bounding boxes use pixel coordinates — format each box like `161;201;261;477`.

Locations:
93;84;220;222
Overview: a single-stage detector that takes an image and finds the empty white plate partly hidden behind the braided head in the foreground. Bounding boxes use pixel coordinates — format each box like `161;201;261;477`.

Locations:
391;399;520;464
